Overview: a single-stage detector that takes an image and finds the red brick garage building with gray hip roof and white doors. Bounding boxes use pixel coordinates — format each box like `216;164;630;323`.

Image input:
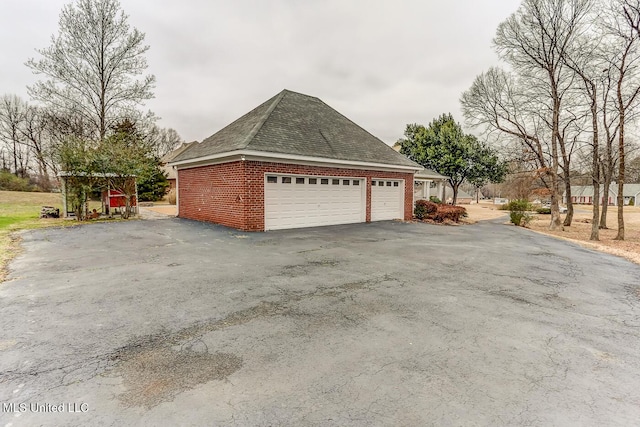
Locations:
170;90;422;231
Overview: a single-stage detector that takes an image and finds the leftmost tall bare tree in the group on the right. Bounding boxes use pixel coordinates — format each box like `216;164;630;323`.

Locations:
461;0;592;229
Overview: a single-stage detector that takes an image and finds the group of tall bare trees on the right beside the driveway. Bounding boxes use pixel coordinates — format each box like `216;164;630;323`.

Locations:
461;0;640;240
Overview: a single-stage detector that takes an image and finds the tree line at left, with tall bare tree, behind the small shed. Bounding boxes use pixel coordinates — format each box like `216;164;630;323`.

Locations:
0;0;181;214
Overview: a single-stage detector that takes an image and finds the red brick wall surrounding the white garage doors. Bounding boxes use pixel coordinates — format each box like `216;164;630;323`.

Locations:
178;161;413;231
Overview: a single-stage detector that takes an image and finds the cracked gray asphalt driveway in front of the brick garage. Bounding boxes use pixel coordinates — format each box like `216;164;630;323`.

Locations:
0;219;640;426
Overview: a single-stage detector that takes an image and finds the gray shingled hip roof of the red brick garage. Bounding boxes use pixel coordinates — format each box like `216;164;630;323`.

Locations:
172;89;422;169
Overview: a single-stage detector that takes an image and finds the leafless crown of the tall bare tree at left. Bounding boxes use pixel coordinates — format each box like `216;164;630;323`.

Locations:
27;0;155;140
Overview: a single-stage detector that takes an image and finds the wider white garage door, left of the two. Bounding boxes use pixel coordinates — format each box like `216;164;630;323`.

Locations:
264;174;366;230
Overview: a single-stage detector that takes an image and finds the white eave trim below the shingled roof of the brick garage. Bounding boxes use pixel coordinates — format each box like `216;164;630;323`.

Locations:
168;150;421;173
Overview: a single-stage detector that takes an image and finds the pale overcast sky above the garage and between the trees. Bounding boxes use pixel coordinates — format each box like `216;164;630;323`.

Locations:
0;0;520;144
